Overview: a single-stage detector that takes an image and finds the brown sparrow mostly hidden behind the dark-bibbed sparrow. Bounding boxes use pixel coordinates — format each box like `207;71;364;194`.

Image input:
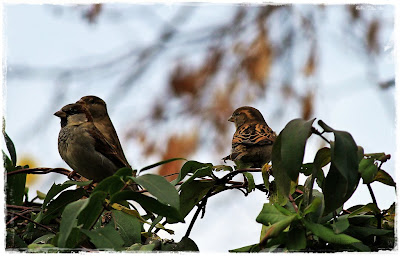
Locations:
76;96;130;167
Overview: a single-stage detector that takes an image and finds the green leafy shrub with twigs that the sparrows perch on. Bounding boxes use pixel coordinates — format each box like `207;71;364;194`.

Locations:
3;119;396;252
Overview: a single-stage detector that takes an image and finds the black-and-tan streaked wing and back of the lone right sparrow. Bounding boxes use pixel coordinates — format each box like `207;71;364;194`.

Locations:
232;123;275;147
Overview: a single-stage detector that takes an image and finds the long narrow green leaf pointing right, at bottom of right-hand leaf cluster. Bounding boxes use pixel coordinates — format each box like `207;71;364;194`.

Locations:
304;219;360;244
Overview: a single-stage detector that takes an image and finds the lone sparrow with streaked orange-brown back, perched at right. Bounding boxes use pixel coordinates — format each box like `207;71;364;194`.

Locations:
222;106;276;169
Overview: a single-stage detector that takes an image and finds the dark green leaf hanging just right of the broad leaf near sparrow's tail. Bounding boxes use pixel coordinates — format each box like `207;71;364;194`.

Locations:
179;180;215;220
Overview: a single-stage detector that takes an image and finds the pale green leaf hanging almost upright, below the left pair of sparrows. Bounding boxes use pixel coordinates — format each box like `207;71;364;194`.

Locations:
58;199;89;248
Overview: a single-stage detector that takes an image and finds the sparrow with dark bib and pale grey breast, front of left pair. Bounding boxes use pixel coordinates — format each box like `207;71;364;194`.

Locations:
54;104;126;182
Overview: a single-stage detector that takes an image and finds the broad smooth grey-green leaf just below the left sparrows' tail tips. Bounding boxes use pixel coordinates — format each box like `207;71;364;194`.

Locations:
131;174;179;210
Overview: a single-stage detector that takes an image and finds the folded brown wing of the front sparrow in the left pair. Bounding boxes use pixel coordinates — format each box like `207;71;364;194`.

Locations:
85;123;129;168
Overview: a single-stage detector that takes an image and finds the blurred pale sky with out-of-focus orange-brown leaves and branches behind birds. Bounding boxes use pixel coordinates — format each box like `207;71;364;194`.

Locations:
3;3;396;252
